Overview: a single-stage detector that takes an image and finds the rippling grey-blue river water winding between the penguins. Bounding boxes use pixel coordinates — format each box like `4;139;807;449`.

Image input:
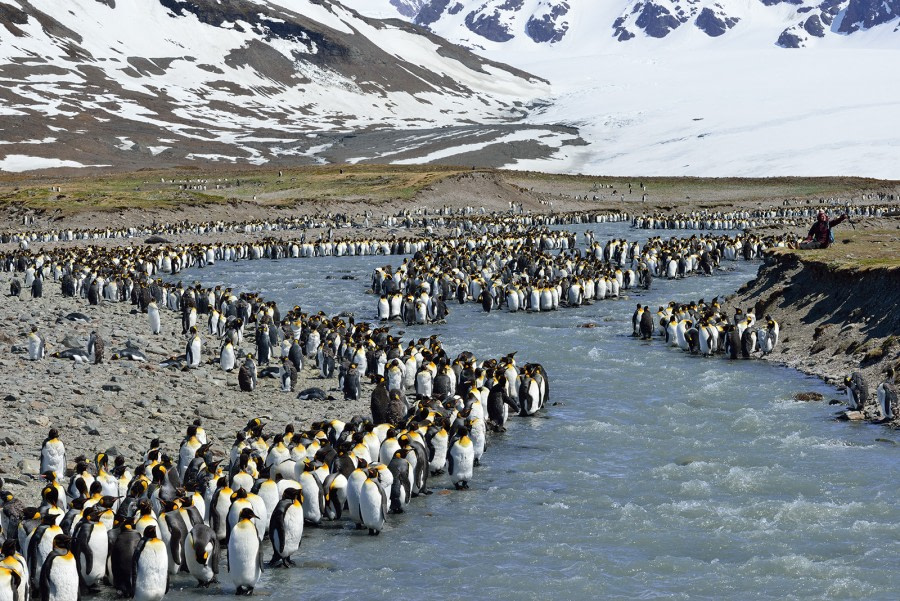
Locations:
167;224;900;601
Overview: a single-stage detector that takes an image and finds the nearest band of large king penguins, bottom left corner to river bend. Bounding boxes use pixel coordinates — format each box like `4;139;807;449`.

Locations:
0;339;550;601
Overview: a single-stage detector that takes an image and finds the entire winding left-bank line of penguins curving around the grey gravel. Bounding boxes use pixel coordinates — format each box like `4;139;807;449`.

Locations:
0;205;552;601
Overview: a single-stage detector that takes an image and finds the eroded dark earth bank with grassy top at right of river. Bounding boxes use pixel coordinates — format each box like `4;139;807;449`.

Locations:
723;225;900;408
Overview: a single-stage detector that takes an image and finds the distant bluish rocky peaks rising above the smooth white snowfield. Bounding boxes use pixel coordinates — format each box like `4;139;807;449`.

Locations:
346;0;900;48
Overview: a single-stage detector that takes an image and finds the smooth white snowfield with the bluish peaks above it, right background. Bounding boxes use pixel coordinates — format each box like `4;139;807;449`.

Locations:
344;0;900;179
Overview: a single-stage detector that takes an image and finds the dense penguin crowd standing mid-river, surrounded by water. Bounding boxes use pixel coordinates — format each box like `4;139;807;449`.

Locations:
372;230;789;325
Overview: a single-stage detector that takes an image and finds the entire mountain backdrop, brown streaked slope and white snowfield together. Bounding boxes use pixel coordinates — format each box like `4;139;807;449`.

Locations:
0;0;900;179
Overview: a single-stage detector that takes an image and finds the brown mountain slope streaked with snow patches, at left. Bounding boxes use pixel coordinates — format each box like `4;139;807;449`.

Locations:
0;0;577;170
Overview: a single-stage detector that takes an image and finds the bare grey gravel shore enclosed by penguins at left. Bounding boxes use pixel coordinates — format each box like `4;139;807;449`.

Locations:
0;273;371;499
